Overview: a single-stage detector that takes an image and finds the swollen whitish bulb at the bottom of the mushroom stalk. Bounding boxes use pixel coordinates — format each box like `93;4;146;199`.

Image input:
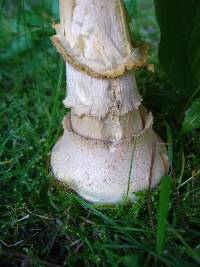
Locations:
51;116;168;204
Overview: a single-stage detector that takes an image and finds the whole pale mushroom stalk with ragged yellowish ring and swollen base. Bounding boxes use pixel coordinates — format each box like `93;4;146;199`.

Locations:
51;0;168;204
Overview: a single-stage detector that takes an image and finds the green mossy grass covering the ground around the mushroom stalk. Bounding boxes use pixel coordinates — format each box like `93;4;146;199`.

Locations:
0;0;200;267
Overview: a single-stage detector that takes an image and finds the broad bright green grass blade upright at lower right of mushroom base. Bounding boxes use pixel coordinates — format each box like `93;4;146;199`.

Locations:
156;176;172;254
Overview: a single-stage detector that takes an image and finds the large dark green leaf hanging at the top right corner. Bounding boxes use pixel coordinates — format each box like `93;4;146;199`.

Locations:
154;0;200;99
